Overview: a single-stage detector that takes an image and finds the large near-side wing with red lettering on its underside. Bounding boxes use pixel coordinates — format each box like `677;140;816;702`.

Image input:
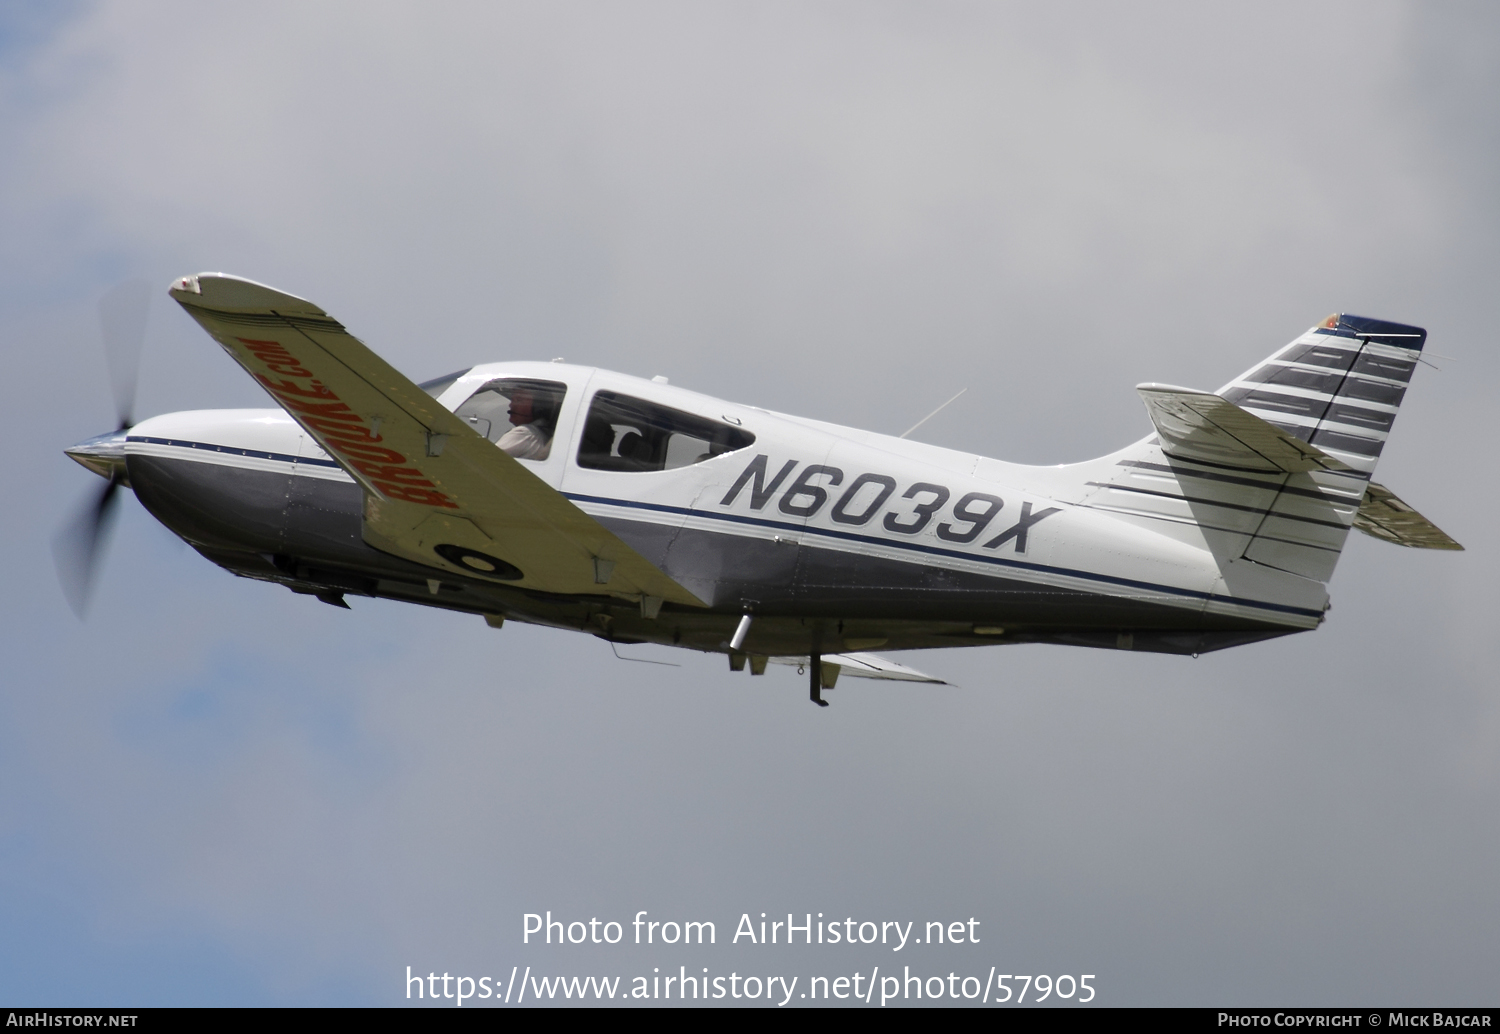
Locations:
171;273;705;611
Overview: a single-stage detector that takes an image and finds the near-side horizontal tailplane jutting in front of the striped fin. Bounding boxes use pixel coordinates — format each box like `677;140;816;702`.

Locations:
1136;384;1349;474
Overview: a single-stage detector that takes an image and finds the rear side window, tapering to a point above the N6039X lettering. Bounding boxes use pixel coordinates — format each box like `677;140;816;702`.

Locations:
578;392;755;471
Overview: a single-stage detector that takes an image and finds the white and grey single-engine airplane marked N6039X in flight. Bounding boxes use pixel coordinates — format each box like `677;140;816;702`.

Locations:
66;273;1463;705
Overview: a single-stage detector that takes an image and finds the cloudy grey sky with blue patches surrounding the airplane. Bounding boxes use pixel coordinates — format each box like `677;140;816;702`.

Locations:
0;0;1500;1007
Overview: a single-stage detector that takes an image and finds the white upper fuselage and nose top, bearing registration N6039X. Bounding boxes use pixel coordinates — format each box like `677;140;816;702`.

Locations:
126;362;1328;642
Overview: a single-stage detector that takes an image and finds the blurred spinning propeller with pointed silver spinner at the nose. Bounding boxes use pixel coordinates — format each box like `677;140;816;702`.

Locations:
53;281;152;618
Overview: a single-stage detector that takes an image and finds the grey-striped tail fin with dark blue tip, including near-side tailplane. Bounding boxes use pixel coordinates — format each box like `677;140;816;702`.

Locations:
1088;315;1427;582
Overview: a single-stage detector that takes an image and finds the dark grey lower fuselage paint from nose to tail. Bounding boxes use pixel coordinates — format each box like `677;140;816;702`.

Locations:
128;455;1287;653
